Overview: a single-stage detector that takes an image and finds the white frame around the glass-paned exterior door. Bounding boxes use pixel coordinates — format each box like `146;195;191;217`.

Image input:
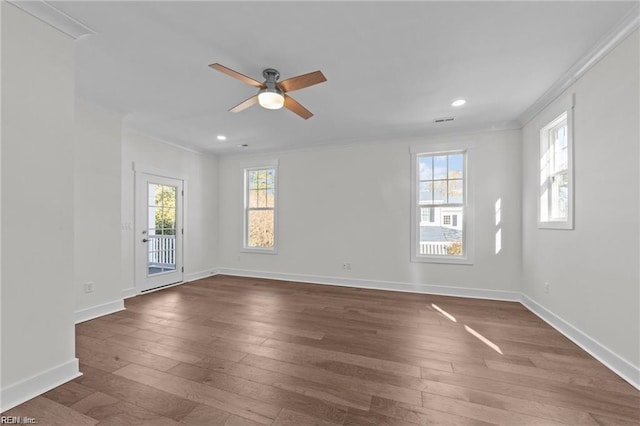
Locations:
132;162;187;294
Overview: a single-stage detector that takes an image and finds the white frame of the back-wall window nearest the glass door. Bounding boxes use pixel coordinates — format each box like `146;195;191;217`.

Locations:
241;160;279;254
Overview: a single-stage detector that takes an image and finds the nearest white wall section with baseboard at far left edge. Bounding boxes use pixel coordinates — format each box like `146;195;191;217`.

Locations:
0;2;78;410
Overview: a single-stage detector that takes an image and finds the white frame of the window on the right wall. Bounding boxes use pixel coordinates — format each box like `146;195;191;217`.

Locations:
536;95;574;230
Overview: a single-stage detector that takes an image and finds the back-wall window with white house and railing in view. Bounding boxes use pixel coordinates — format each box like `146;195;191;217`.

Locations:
412;150;471;263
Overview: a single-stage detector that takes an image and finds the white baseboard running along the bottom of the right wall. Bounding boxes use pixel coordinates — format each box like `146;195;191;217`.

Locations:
520;294;640;390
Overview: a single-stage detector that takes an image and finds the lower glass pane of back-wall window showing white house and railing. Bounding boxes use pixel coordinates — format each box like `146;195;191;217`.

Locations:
418;207;464;256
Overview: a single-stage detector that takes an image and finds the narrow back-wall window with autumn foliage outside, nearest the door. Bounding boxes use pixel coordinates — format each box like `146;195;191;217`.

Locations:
244;167;276;252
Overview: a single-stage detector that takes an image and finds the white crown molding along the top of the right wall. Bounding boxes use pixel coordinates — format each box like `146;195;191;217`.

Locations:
518;4;640;126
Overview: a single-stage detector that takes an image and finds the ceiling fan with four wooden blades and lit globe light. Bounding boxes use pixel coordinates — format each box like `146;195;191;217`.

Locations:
209;63;327;120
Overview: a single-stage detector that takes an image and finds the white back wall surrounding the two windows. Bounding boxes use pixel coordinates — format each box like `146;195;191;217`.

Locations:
218;131;521;298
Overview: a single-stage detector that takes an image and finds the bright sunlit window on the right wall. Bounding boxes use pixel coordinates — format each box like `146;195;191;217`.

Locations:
538;103;573;229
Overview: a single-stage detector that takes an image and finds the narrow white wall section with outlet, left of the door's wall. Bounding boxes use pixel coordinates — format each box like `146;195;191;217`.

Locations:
73;101;124;321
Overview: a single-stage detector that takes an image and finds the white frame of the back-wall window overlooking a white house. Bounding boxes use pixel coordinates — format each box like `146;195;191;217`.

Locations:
410;148;475;265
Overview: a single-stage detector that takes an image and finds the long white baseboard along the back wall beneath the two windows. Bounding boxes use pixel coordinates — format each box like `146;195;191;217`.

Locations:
217;268;520;302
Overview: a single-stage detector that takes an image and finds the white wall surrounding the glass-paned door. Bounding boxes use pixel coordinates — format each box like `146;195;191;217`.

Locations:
121;131;218;296
